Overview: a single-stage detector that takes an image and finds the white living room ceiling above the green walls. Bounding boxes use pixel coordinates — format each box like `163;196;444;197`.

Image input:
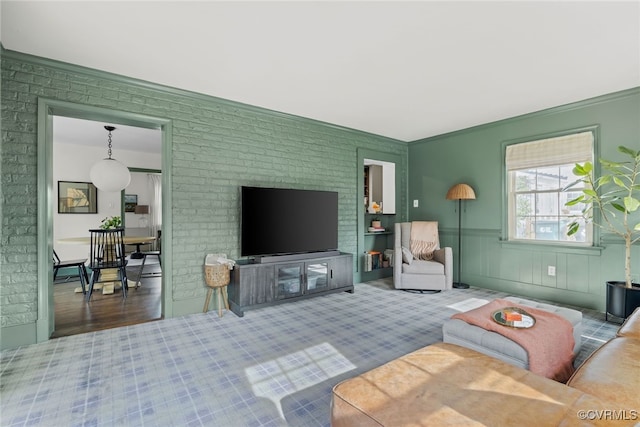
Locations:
1;0;640;141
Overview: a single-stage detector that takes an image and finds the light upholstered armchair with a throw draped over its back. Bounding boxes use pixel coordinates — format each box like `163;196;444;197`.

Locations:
393;221;453;291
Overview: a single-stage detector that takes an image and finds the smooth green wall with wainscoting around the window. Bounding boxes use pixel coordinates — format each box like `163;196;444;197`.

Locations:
408;88;640;310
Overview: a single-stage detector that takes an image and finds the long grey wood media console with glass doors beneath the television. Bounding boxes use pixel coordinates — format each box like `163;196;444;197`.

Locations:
228;252;353;316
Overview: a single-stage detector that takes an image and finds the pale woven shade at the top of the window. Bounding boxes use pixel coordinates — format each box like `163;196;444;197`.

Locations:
506;131;593;171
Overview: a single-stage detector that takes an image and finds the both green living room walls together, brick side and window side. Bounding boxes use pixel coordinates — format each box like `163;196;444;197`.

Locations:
0;47;640;348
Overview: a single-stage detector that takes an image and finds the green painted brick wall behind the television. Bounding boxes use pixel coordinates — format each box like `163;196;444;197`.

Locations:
0;50;408;327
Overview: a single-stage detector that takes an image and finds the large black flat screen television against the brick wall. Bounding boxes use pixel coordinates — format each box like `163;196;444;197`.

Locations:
240;187;338;256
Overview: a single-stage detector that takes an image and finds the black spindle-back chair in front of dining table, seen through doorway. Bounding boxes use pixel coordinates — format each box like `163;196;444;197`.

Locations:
87;228;127;302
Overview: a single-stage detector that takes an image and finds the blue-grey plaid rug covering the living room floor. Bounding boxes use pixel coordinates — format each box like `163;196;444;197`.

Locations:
0;279;617;427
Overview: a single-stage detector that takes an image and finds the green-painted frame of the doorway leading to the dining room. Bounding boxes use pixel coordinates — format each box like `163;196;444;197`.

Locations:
36;99;172;342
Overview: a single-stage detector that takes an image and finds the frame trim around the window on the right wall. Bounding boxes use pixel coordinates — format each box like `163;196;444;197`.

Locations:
500;125;601;248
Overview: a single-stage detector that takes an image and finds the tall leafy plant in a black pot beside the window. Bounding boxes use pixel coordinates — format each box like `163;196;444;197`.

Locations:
565;146;640;318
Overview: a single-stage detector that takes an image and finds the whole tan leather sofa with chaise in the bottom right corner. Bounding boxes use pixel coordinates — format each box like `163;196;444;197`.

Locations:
331;309;640;427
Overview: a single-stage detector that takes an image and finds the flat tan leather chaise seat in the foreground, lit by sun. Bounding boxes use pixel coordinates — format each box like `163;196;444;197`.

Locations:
331;343;632;427
